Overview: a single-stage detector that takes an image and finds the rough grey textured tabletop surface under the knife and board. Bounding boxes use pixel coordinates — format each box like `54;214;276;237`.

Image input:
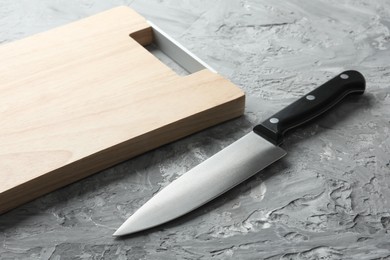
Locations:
0;0;390;259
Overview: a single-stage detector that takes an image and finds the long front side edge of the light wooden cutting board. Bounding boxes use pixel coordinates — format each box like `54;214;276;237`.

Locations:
0;92;245;215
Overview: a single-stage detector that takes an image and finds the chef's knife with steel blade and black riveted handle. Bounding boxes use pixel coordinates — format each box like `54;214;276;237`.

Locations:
113;70;365;236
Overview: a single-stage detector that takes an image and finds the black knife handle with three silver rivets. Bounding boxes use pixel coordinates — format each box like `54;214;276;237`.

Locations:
253;70;366;145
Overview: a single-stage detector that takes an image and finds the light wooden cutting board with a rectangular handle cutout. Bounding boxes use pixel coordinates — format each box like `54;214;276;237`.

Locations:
0;7;244;213
